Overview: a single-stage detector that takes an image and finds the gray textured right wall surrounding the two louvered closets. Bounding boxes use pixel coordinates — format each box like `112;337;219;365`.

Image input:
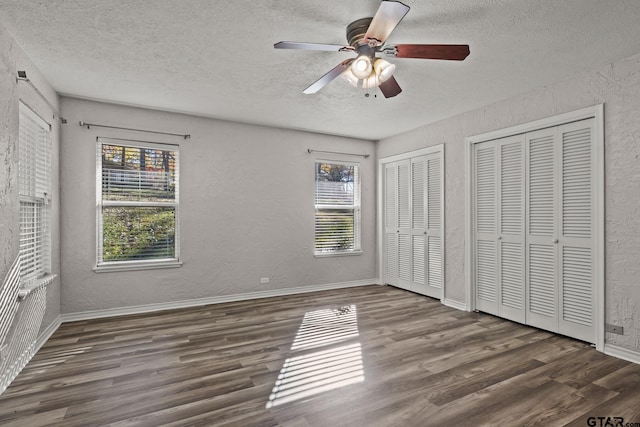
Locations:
377;50;640;351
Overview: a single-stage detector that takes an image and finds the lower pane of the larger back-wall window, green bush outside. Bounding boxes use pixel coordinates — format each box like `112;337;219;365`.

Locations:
102;206;176;261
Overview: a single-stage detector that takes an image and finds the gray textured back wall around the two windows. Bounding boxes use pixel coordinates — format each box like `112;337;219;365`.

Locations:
61;98;376;313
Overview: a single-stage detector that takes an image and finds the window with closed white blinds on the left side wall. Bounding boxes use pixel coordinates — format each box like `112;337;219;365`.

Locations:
18;104;51;287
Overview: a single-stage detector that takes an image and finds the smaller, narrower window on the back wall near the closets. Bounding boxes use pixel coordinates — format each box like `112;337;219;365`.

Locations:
315;162;360;256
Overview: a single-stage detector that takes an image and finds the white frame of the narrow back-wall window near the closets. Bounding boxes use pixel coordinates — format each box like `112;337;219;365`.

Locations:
313;159;362;258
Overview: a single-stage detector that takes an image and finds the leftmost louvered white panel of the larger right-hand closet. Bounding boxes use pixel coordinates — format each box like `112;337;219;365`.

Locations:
473;141;499;314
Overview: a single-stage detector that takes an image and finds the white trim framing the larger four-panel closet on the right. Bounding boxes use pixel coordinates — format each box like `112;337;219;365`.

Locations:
464;104;605;351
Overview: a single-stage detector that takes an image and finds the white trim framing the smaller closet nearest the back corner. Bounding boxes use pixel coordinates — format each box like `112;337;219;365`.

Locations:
376;144;446;301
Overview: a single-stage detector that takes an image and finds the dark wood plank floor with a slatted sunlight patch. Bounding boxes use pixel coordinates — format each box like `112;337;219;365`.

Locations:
0;286;640;427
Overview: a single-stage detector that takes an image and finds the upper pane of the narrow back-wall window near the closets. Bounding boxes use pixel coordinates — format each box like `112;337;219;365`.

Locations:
316;163;357;206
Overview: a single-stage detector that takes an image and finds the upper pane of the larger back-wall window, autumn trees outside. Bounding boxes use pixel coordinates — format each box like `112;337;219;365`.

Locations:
102;144;177;202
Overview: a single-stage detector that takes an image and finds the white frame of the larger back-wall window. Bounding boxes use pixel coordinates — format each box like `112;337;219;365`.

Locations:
94;137;182;273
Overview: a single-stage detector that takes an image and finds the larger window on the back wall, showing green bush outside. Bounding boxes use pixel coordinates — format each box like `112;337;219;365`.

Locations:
96;138;180;271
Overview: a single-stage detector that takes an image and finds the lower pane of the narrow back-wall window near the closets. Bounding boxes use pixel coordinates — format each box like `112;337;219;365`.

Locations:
316;209;356;253
